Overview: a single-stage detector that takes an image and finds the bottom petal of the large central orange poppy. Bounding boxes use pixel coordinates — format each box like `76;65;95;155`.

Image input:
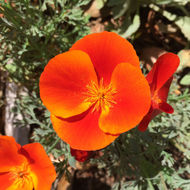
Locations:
51;111;117;151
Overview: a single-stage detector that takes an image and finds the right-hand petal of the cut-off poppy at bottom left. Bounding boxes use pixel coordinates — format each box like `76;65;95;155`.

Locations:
21;143;56;190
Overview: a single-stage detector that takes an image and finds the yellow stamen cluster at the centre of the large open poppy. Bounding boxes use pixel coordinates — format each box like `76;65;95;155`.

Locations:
85;78;116;111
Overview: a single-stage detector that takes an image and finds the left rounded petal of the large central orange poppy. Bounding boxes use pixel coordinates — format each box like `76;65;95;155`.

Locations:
40;50;97;118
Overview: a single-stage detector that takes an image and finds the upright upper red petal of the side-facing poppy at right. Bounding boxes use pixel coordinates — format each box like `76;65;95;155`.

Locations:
146;53;180;91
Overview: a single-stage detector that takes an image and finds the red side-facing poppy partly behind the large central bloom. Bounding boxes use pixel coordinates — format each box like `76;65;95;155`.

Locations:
138;53;180;131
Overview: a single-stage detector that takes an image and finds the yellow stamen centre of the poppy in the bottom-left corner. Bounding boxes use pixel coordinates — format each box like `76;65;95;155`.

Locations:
10;163;33;189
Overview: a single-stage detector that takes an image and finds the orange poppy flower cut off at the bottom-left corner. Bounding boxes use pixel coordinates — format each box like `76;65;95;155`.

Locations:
0;136;56;190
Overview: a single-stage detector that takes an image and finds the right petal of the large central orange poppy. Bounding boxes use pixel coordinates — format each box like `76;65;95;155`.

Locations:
99;63;151;134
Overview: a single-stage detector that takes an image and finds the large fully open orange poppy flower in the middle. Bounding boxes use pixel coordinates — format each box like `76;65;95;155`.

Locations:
40;32;151;151
